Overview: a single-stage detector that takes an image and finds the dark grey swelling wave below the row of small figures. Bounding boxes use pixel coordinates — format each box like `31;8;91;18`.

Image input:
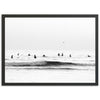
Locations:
5;61;95;67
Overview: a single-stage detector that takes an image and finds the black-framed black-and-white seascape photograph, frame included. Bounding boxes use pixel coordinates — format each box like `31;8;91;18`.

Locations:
2;14;98;86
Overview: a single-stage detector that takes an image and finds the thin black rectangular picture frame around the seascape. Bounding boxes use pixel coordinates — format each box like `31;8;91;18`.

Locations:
1;14;98;86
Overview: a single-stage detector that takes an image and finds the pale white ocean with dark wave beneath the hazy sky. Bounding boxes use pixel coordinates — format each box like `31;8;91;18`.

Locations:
5;50;95;83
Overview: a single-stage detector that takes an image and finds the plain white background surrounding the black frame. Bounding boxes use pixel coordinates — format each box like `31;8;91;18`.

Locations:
0;0;100;100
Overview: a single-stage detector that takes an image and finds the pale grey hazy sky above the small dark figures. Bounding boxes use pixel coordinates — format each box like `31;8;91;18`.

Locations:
5;18;95;50
